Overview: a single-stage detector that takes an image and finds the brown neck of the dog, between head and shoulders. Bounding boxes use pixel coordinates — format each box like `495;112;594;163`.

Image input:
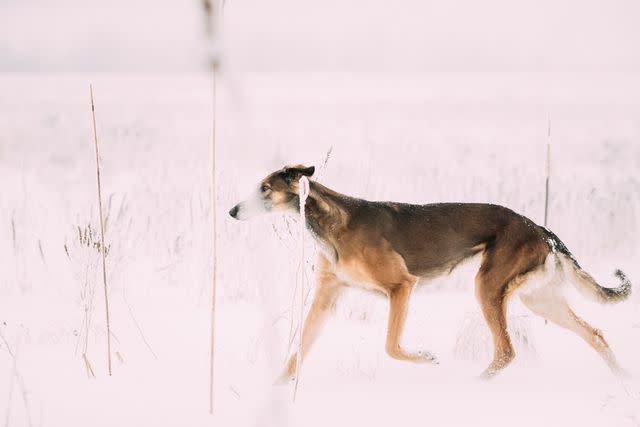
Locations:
305;181;356;254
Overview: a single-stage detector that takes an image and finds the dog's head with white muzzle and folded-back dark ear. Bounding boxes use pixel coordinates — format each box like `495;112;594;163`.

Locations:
229;165;316;220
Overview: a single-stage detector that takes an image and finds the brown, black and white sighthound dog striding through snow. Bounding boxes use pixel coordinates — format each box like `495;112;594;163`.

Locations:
229;165;631;380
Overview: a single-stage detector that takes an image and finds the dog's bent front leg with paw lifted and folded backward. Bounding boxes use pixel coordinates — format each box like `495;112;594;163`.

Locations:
386;281;438;363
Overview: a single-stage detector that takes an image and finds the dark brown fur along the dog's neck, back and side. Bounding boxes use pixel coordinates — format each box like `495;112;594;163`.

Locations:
306;182;548;276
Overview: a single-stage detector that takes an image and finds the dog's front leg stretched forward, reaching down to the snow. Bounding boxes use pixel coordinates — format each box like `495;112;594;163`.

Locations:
277;262;342;384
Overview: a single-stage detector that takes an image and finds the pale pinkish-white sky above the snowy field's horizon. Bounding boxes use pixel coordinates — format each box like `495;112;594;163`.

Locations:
0;0;640;71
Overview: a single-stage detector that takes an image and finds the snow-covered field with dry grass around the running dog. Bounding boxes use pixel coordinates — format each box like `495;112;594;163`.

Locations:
0;74;640;426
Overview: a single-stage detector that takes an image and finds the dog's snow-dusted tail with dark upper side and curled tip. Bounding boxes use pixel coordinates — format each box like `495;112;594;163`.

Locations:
544;228;631;304
